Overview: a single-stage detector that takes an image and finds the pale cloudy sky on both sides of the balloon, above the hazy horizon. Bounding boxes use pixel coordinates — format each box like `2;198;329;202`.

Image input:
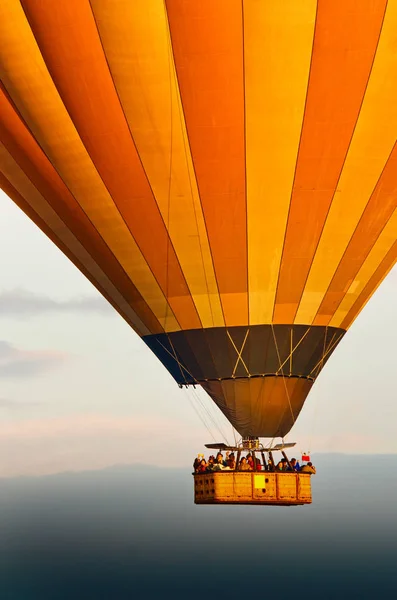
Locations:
0;191;397;477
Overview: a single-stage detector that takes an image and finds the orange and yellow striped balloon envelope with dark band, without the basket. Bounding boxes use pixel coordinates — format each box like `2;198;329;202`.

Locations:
0;0;397;504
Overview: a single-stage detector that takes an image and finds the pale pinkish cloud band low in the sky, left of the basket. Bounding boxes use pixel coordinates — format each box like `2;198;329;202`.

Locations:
0;413;205;477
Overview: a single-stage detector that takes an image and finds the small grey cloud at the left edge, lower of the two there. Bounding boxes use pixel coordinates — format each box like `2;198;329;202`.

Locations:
0;340;66;378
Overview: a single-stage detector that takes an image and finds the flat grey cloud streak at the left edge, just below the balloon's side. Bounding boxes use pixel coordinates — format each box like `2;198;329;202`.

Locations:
0;289;114;317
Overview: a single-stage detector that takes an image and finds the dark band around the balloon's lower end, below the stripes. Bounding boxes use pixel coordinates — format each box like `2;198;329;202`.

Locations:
143;325;345;385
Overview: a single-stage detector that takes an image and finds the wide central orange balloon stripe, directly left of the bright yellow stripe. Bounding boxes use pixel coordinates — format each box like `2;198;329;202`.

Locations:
166;0;248;325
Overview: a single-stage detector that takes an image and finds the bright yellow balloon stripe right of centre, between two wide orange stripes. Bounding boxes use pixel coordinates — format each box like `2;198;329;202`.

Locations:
244;0;317;325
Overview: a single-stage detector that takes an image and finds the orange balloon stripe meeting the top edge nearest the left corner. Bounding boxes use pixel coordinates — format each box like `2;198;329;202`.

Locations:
22;0;201;329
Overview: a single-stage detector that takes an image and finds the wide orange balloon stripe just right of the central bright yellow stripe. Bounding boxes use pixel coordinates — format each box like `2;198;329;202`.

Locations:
273;0;386;323
